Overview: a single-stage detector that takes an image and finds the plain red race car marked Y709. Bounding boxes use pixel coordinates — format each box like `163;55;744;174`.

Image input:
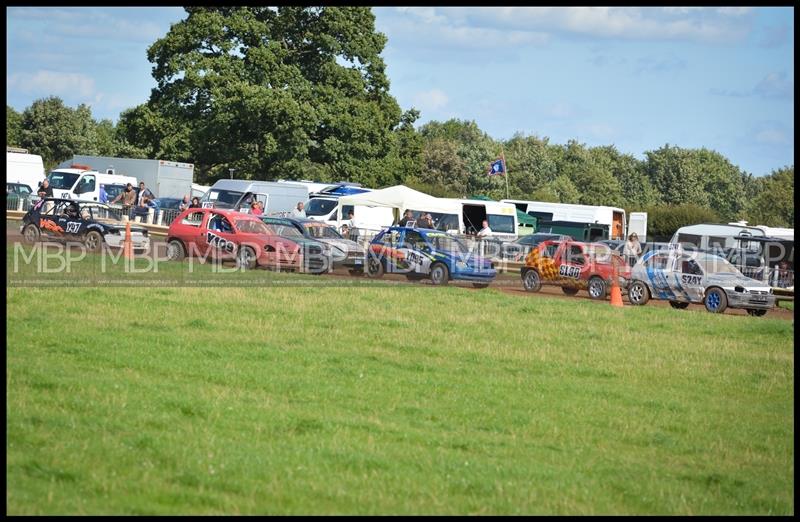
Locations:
167;208;303;270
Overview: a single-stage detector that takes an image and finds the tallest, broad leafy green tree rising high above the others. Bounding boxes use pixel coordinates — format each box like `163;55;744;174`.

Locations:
141;6;410;182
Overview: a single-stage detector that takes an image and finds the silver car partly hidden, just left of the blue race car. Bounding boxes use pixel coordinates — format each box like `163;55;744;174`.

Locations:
261;216;366;275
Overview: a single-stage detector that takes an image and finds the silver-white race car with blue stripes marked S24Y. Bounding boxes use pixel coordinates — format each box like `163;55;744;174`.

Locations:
628;246;775;316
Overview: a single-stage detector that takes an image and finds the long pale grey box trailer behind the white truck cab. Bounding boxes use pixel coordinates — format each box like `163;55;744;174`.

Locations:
59;155;194;198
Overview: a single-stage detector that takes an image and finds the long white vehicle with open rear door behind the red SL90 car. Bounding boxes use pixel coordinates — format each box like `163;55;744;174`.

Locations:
500;199;636;241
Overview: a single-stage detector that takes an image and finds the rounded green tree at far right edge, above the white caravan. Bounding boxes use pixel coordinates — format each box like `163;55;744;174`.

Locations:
744;165;794;228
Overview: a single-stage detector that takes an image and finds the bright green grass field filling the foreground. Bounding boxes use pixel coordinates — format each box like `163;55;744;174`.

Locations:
6;248;794;514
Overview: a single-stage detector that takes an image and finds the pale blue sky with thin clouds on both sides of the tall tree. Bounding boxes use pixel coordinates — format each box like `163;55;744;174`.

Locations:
6;7;794;175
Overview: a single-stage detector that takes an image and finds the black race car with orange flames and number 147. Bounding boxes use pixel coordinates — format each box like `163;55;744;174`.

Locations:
20;198;150;252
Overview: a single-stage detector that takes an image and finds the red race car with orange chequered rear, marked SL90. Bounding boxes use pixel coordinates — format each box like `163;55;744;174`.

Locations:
520;240;630;299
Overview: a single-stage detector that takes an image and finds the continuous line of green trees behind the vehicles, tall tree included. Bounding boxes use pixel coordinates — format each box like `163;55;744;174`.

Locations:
6;6;794;231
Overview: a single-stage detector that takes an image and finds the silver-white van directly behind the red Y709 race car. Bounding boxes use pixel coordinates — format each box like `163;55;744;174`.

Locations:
200;179;308;215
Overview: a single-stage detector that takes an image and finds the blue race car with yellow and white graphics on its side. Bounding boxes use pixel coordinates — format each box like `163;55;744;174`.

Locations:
367;227;497;288
